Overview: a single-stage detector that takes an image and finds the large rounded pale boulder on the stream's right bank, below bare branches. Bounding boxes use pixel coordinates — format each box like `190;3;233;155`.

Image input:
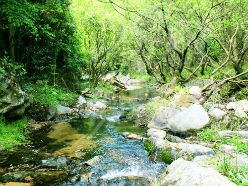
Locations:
148;104;209;132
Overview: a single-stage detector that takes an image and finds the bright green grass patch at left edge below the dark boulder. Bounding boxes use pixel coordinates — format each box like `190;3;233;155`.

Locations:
0;118;28;151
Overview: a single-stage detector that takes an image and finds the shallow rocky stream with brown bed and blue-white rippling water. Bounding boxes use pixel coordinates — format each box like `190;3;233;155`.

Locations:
0;89;166;186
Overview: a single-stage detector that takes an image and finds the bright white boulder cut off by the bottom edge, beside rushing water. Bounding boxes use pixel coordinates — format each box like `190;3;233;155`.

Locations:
154;158;236;186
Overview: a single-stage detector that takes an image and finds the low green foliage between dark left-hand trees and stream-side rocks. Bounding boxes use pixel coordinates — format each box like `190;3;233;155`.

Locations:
25;81;78;106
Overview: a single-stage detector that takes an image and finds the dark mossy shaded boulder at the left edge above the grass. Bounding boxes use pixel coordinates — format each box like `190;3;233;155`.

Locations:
0;76;30;118
